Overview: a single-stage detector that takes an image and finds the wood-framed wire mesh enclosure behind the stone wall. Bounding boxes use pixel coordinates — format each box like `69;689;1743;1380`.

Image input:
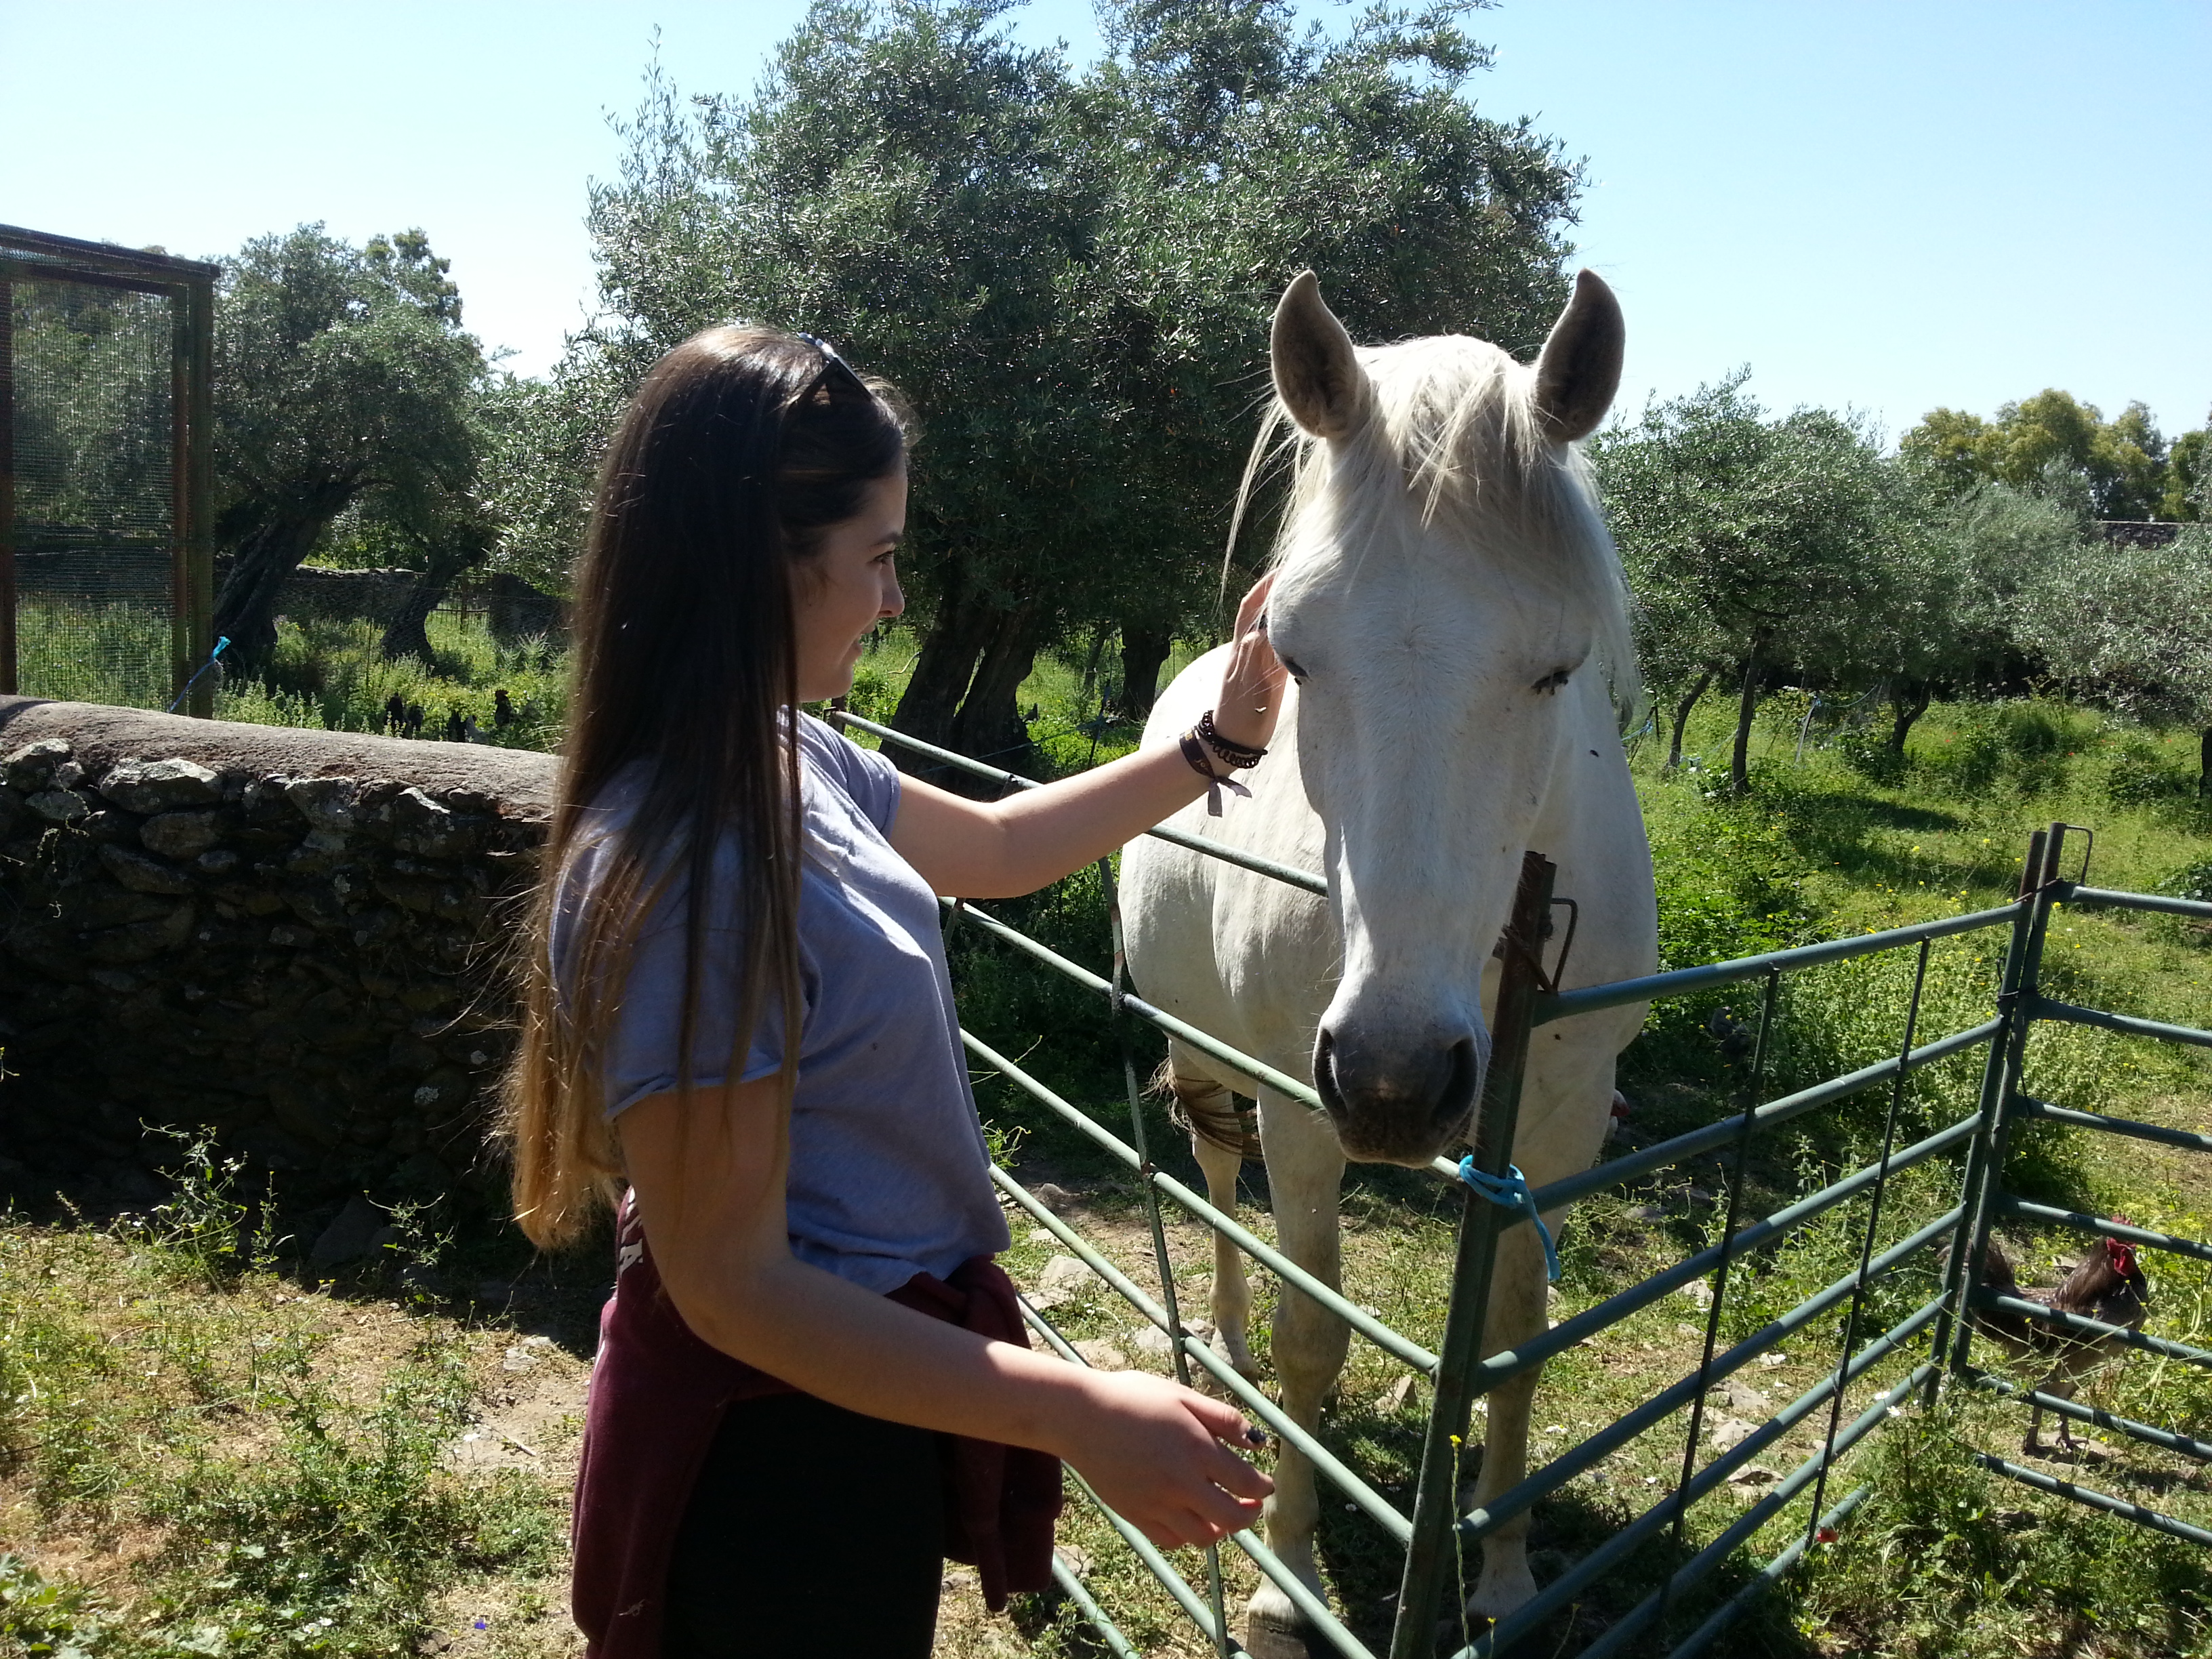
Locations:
0;226;215;714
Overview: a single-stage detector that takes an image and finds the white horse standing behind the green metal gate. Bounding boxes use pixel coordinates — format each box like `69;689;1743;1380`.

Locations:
1122;272;1657;1659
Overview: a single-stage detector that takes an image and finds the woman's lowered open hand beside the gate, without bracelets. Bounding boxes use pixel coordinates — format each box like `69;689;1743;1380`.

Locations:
1059;1372;1274;1549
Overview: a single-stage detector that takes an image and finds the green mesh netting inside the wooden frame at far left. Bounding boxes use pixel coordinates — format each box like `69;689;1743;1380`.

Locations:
7;266;177;708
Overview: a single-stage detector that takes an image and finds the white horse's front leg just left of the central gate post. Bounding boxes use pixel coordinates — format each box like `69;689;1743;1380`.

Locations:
1246;1092;1351;1659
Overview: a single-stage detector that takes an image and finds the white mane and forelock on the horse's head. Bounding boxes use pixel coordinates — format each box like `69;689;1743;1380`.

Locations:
1230;334;1641;717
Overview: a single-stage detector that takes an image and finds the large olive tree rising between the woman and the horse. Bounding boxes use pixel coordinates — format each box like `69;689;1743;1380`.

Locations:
571;0;1579;754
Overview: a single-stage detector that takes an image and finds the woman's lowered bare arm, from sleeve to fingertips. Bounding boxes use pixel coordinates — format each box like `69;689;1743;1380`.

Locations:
615;1078;1272;1547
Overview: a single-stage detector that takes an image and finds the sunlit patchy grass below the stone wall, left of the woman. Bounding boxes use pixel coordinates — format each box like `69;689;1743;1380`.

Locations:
0;1148;564;1659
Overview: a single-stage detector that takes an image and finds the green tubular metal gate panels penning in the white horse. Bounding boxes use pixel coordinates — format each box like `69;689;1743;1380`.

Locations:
836;712;2212;1659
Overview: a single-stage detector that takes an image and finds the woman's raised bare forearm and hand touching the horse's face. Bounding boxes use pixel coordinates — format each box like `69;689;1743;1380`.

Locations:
891;577;1283;898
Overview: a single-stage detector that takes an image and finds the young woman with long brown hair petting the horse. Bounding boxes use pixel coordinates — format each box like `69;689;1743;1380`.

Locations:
511;327;1283;1659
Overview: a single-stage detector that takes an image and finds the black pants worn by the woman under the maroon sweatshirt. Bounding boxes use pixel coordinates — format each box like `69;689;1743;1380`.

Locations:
661;1393;945;1659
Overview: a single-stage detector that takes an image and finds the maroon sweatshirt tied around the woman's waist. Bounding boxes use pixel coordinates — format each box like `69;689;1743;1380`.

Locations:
571;1195;1059;1659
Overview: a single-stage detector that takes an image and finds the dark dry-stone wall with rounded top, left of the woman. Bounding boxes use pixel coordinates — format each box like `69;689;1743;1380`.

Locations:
0;697;553;1201
